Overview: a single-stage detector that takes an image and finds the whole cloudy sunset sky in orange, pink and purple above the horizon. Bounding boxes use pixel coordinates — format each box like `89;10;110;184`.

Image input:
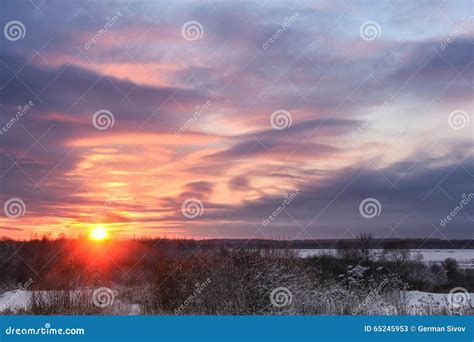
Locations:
0;0;474;239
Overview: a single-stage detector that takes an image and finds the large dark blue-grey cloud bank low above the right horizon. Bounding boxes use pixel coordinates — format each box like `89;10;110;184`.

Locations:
221;158;474;238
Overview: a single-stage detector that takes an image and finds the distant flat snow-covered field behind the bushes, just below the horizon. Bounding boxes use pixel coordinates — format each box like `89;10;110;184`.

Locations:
297;249;474;268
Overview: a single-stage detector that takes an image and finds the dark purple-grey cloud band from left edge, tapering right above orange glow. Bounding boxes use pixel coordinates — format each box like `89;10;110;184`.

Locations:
0;54;203;130
